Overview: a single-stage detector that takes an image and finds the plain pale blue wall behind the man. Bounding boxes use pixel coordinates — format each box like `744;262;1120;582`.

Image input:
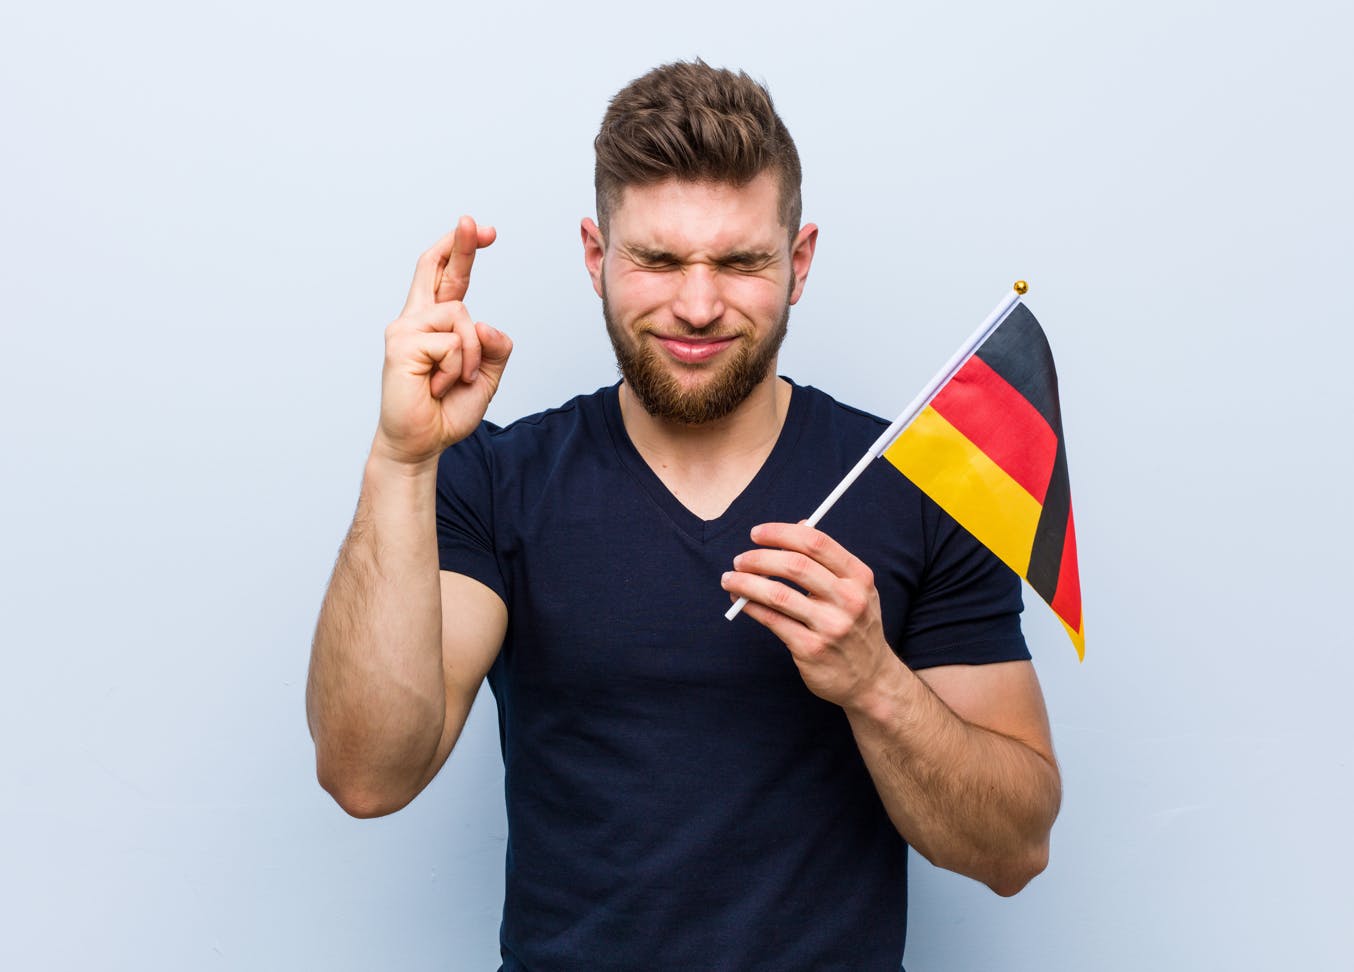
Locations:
0;0;1354;972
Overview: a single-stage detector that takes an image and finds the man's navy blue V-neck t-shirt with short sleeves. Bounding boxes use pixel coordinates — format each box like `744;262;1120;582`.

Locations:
437;386;1029;972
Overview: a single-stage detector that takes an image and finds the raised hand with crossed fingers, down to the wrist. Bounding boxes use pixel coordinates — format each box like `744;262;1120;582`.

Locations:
372;217;512;466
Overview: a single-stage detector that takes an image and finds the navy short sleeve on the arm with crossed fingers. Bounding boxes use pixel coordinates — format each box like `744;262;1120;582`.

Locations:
437;422;508;602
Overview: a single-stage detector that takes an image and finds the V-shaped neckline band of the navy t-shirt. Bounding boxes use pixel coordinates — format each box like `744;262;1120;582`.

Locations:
603;378;808;543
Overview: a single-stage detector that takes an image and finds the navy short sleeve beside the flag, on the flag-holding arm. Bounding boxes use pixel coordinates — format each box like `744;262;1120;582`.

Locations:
902;498;1030;669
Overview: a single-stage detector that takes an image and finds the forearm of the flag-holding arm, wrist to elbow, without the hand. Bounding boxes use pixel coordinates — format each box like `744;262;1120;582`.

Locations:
845;662;1062;895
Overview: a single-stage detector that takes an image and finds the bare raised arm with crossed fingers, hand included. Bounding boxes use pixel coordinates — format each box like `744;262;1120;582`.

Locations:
306;217;512;816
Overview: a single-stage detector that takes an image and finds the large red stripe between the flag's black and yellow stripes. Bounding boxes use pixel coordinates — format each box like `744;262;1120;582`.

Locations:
932;357;1057;502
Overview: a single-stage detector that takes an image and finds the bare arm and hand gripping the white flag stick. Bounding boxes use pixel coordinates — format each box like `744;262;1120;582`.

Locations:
724;524;1062;895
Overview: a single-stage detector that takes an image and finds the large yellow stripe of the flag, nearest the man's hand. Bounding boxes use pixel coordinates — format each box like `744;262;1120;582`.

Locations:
884;406;1041;577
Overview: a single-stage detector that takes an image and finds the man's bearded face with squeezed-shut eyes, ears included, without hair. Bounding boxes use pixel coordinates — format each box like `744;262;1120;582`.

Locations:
584;173;816;425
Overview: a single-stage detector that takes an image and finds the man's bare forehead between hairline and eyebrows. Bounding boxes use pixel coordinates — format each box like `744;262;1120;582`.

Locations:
608;172;785;255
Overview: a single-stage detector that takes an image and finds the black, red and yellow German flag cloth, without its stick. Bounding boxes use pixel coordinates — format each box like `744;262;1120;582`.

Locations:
884;305;1086;658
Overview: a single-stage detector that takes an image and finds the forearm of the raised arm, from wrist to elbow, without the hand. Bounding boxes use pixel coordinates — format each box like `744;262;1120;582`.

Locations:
306;455;445;815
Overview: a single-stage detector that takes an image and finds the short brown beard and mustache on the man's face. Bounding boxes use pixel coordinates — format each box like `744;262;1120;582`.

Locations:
601;283;789;425
